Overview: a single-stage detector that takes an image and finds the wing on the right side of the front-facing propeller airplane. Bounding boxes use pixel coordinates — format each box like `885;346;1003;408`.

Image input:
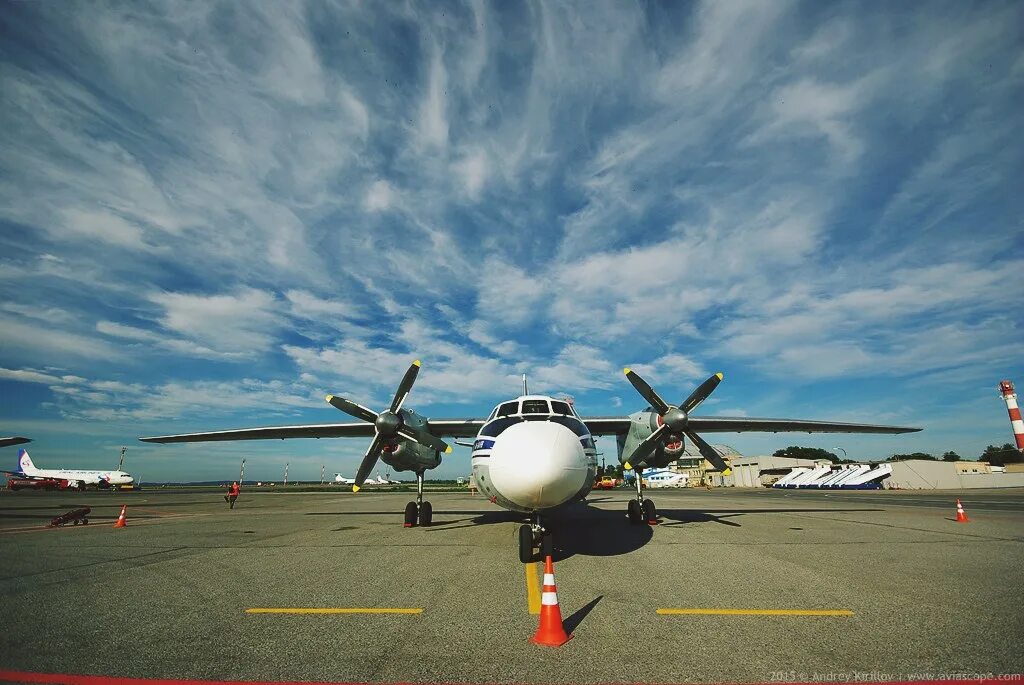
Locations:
583;417;921;435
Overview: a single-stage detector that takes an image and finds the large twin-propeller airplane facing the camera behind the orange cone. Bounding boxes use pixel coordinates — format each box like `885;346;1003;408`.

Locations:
139;359;921;563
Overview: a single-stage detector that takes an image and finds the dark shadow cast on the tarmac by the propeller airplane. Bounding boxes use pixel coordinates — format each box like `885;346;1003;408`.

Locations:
306;502;885;561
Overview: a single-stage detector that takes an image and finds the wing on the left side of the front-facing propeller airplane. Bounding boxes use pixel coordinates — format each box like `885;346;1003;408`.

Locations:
138;419;484;443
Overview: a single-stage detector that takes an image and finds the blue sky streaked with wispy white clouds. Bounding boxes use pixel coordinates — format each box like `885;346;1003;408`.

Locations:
0;2;1024;480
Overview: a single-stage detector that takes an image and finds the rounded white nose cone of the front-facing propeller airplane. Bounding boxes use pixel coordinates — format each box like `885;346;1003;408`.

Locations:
489;421;587;509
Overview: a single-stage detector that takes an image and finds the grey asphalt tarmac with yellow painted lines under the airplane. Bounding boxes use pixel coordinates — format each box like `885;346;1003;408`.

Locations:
0;489;1024;683
